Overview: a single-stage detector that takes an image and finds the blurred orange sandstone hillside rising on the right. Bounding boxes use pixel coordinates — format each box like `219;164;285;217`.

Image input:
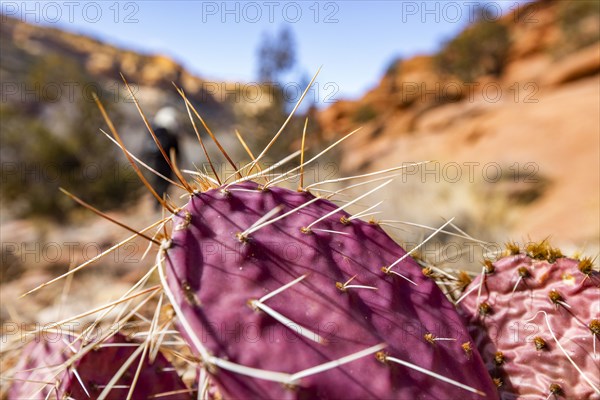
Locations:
319;1;600;253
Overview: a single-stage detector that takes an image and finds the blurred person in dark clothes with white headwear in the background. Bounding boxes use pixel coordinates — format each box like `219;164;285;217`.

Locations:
144;107;179;208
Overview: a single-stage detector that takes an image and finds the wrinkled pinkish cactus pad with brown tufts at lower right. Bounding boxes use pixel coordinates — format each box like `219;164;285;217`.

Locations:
460;242;600;399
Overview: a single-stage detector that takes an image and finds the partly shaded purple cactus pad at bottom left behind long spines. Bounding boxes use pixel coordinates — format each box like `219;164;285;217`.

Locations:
9;332;191;400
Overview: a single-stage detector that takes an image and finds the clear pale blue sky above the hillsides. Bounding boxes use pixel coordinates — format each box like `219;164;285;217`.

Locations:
1;0;523;102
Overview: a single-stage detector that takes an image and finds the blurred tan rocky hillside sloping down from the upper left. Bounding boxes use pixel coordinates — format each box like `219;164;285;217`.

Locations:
0;15;282;134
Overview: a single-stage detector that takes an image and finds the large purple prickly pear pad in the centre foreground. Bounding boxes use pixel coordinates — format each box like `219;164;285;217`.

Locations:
159;181;497;399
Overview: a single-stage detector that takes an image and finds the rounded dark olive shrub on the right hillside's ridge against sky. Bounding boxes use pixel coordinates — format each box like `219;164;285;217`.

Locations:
434;18;510;82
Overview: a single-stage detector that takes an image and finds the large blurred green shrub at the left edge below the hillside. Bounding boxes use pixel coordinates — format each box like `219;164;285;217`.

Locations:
0;56;140;219
